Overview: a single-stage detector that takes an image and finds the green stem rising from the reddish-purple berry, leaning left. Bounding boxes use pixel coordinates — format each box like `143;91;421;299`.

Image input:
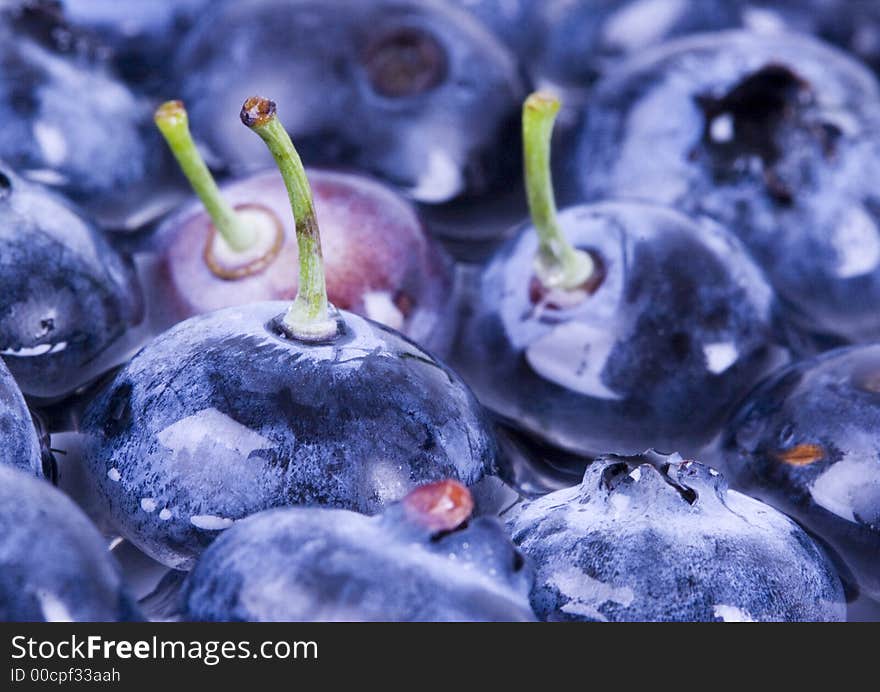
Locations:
154;101;256;252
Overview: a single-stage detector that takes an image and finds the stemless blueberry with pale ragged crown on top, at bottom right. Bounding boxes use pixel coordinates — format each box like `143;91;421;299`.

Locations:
509;452;846;622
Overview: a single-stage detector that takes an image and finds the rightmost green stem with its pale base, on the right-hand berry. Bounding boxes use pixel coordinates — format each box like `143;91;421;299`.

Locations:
523;92;595;290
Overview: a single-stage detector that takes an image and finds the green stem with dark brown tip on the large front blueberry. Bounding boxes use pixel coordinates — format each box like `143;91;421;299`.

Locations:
241;96;338;341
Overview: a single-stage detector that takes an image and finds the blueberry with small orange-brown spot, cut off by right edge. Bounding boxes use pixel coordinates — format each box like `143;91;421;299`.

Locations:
721;345;880;600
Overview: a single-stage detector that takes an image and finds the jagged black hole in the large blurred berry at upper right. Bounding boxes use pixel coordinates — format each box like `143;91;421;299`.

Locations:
696;64;816;204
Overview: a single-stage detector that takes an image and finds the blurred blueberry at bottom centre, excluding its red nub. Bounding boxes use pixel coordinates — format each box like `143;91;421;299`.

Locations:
182;506;534;622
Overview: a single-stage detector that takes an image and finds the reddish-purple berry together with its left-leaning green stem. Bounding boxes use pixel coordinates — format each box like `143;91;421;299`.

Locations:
149;101;456;354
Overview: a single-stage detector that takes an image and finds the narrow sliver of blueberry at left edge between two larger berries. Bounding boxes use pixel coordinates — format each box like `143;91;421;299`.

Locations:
0;361;43;476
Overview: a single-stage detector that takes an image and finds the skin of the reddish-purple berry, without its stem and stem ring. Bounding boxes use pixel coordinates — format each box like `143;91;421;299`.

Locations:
148;170;455;353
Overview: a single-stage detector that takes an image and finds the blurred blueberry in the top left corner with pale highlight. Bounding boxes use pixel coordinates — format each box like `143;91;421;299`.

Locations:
0;3;161;223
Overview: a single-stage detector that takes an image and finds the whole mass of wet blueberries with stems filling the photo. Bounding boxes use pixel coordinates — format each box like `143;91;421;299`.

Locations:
0;0;880;622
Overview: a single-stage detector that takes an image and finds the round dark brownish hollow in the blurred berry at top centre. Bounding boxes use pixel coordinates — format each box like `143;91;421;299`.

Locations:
363;27;447;98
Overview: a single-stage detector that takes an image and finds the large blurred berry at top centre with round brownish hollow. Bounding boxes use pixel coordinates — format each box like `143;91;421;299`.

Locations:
175;0;524;203
